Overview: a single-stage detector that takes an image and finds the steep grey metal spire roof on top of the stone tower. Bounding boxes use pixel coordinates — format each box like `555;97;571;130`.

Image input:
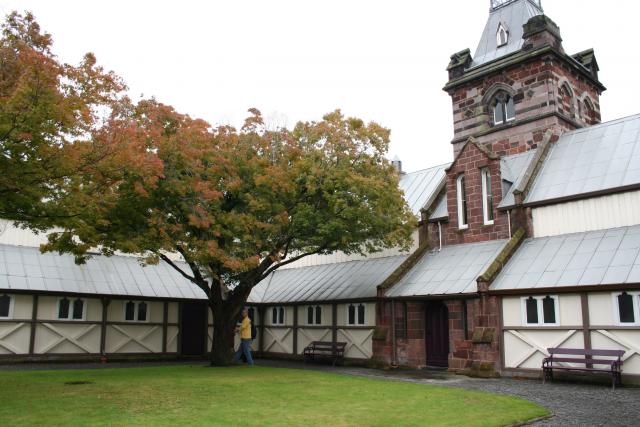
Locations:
471;0;544;67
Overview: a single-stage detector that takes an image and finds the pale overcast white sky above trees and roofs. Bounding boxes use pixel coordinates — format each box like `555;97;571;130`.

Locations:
0;0;640;171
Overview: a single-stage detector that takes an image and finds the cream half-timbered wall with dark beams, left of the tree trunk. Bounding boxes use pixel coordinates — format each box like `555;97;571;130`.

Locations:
0;294;179;359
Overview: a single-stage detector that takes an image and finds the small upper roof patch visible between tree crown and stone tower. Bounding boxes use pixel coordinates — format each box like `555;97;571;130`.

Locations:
400;163;451;216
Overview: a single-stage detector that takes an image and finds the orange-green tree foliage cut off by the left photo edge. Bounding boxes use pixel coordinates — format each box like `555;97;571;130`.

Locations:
0;12;125;227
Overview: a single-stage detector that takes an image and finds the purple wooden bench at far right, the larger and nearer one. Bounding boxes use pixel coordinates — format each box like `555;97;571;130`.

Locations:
542;348;625;390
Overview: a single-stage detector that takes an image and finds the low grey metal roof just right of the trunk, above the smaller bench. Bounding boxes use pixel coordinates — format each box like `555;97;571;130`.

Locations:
249;256;407;304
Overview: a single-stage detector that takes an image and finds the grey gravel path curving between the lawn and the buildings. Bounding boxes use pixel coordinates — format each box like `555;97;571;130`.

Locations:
0;359;640;426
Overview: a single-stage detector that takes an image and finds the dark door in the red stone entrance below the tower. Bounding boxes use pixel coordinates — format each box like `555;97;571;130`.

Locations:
425;302;449;368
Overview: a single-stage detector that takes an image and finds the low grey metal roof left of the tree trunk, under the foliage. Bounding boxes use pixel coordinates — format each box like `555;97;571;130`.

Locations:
0;245;206;299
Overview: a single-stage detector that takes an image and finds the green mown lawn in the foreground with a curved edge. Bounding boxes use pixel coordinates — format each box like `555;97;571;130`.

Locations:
0;366;547;427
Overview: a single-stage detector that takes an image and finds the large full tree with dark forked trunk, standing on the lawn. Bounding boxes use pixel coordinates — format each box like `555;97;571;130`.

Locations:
45;101;415;365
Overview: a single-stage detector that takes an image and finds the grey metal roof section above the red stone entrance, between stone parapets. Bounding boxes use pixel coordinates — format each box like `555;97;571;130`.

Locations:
387;240;507;297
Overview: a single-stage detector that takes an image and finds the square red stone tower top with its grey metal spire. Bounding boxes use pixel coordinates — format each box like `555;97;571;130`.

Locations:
444;0;605;156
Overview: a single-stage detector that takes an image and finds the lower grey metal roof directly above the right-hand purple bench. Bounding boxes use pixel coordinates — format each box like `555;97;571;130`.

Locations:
491;225;640;290
